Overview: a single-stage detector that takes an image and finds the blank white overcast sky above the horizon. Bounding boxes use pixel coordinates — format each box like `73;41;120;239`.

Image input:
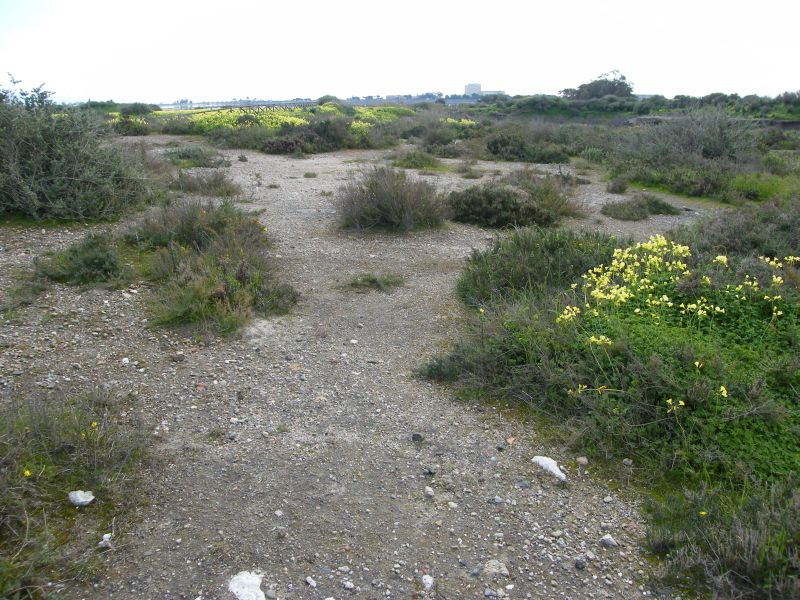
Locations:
0;0;800;102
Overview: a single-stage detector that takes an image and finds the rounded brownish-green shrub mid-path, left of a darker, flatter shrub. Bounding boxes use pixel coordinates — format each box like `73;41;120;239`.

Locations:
336;167;446;231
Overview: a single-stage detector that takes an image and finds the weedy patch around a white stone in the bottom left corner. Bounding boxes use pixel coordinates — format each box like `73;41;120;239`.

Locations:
0;392;147;600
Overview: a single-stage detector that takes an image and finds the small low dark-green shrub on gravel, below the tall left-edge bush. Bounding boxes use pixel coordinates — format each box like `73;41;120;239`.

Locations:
36;233;123;285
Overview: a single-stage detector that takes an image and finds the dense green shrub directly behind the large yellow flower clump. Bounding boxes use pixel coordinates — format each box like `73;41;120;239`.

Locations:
456;227;619;307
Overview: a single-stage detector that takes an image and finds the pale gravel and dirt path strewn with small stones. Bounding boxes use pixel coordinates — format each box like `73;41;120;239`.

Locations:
0;139;708;600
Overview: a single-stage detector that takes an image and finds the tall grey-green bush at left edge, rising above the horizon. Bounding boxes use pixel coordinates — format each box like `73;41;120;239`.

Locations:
0;84;146;220
